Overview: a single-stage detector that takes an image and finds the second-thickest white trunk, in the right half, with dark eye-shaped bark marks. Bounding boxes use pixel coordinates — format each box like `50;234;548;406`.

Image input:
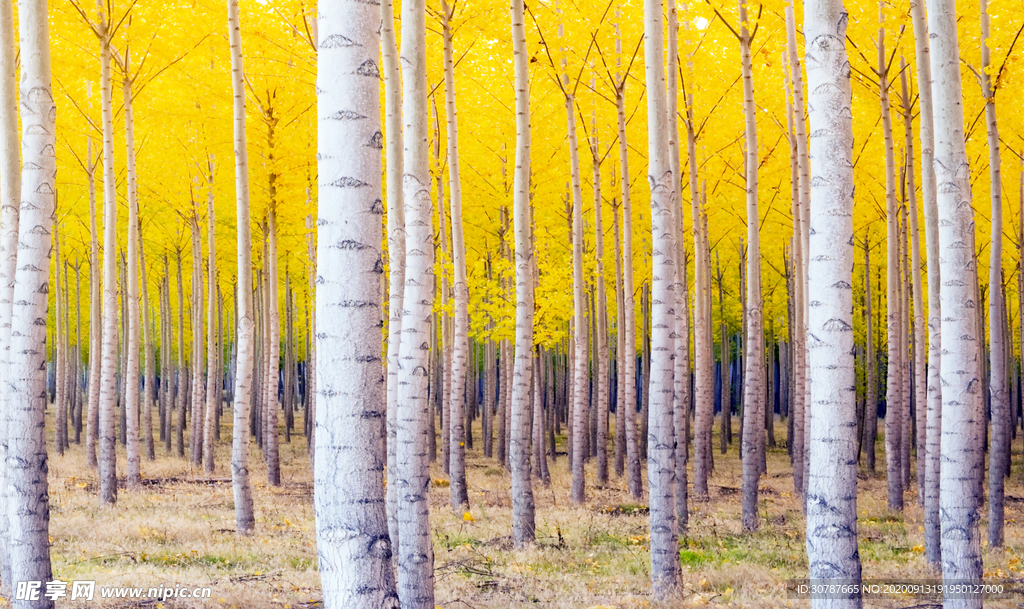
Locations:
802;0;860;609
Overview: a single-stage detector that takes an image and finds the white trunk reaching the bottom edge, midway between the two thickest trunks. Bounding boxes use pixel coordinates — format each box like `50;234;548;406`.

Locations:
644;0;680;601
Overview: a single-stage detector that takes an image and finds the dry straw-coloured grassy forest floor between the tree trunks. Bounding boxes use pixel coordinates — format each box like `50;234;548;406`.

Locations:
44;411;1024;609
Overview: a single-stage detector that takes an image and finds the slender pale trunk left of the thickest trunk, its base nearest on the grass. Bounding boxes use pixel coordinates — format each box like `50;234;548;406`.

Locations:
227;0;256;535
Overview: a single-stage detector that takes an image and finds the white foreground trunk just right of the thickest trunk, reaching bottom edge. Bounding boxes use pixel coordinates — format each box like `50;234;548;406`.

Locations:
393;0;434;609
